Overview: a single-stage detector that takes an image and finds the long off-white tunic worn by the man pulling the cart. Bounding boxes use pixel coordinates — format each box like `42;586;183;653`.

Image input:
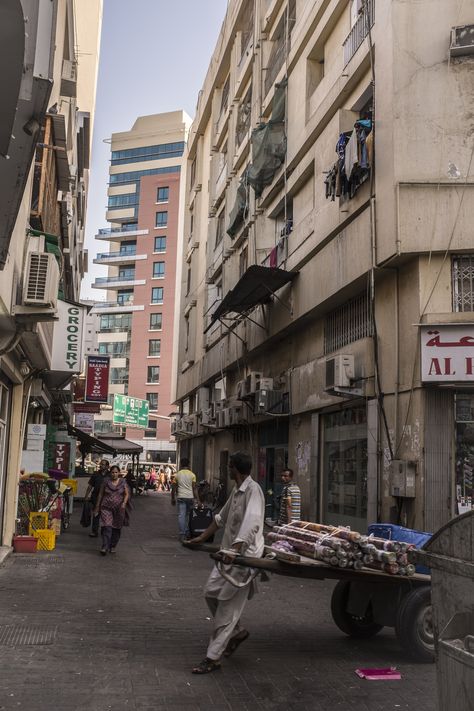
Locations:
204;476;265;600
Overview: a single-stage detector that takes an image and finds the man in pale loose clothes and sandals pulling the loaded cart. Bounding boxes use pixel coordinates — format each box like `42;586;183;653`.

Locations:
187;452;265;674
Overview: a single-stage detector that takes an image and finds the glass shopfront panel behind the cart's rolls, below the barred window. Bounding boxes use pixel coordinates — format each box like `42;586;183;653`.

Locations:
322;406;367;533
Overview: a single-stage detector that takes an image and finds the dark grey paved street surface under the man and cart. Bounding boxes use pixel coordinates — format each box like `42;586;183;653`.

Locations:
0;493;437;711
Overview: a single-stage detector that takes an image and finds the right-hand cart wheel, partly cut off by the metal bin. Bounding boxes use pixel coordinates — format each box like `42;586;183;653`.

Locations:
395;585;435;663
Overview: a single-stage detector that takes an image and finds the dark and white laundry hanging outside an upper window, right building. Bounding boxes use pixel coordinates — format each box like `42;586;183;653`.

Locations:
324;119;373;200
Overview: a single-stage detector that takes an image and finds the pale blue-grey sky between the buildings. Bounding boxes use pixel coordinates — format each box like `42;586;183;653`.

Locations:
81;0;227;300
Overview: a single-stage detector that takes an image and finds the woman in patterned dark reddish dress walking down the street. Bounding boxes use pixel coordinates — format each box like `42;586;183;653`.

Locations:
94;466;130;555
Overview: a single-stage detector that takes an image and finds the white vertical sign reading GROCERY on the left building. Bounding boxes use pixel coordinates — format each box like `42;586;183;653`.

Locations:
51;299;86;373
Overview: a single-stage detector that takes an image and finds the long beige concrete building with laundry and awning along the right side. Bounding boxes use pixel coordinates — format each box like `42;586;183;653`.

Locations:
176;0;474;531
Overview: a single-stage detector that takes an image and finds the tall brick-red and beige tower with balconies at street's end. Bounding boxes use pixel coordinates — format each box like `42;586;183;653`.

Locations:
93;111;190;461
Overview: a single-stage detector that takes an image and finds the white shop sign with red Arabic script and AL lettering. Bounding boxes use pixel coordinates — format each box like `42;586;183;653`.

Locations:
420;325;474;383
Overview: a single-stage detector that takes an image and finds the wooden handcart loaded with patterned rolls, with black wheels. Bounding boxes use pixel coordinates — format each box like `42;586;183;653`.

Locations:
191;521;434;662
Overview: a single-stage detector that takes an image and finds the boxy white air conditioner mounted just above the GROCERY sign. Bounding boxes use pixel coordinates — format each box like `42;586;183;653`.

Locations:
23;252;59;309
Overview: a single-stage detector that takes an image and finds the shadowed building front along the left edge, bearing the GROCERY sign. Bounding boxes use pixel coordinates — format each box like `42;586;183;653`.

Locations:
0;0;102;546
